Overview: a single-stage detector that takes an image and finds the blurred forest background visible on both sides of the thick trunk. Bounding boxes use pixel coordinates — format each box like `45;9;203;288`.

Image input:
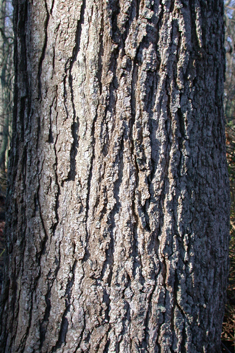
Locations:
0;0;235;353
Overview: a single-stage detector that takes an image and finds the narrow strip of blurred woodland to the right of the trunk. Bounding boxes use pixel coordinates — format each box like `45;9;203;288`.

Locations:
222;0;235;351
